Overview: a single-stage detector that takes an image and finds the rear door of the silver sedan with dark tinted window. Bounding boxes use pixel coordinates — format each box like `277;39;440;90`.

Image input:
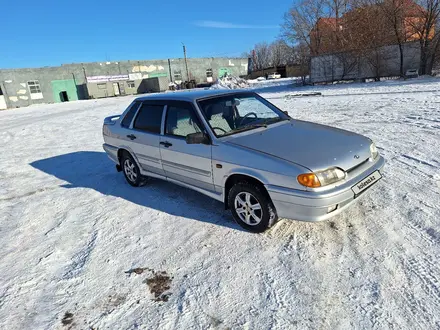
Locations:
127;101;165;176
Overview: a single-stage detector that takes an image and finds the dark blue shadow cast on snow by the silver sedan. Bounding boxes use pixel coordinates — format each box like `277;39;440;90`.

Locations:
30;151;242;231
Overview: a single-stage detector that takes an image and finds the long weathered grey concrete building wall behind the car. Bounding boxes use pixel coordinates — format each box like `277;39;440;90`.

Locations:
0;58;249;108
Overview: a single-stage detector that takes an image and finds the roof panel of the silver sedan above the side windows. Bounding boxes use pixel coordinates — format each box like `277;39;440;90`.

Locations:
136;89;250;102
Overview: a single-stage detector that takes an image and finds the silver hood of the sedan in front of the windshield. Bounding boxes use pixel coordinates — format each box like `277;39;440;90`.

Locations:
227;120;371;171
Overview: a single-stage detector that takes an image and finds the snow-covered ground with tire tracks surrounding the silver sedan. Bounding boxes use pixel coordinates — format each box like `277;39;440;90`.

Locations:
0;79;440;330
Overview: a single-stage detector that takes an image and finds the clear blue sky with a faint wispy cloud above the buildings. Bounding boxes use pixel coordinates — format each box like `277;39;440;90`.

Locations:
0;0;292;68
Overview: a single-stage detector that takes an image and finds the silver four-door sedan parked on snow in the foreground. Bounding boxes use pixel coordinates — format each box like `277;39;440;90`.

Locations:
103;90;384;232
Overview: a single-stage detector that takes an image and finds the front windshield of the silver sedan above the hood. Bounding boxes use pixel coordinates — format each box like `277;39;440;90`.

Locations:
198;93;289;137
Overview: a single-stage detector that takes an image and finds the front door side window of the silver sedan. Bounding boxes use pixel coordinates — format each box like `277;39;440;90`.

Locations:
165;103;202;137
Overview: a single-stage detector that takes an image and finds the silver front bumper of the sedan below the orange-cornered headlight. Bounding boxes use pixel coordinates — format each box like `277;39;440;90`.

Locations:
266;156;385;221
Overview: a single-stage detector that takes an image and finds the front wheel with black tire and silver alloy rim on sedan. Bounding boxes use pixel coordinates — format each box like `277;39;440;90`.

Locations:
228;182;278;233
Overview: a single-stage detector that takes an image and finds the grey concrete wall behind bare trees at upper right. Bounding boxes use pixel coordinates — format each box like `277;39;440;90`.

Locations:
310;43;420;83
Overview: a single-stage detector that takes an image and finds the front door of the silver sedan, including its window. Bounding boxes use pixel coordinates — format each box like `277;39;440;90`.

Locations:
160;101;214;191
